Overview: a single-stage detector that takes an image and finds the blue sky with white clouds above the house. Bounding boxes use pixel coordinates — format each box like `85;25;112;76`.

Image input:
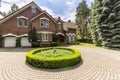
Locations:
0;0;94;22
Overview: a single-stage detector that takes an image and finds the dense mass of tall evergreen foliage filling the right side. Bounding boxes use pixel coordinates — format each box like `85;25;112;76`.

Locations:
91;0;120;49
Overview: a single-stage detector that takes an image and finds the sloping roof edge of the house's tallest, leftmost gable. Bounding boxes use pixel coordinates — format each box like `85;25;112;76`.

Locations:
0;1;42;23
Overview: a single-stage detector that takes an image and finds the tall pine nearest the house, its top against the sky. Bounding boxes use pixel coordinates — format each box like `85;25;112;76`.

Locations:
76;0;90;39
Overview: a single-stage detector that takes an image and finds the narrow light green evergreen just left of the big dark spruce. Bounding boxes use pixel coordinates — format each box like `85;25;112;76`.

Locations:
90;0;102;45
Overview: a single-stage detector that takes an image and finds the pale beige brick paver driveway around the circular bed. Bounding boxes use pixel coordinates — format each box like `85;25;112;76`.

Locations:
0;46;120;80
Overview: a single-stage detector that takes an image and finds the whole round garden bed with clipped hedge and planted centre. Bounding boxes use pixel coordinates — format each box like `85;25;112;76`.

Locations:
26;48;81;69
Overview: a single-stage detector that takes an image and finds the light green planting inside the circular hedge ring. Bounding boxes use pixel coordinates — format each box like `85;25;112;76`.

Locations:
36;49;73;57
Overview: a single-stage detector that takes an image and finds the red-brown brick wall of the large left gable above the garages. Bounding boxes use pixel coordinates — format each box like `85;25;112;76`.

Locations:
0;7;41;35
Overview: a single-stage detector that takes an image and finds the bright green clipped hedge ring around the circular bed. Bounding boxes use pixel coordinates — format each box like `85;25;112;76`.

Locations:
26;48;81;69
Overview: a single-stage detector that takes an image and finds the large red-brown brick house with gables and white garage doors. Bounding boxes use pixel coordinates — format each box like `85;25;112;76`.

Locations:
0;2;76;47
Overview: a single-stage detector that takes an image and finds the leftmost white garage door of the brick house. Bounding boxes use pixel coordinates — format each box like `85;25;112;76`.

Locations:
4;37;16;47
